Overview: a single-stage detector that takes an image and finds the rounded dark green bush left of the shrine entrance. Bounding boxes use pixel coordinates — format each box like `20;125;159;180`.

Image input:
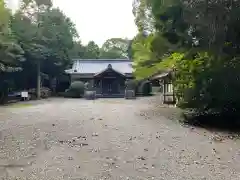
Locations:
65;81;85;98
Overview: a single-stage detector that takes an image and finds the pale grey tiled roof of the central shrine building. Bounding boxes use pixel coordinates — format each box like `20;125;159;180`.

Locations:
65;59;133;74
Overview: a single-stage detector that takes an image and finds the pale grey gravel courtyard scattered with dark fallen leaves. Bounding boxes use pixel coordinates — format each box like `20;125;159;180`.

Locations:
0;97;240;180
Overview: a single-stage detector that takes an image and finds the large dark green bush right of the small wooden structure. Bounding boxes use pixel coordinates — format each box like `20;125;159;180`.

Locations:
171;53;240;126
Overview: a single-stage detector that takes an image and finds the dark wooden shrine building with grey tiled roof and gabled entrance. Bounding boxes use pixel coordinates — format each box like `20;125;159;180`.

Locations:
65;59;134;96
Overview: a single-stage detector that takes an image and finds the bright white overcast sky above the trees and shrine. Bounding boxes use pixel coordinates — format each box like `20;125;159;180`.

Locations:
6;0;137;46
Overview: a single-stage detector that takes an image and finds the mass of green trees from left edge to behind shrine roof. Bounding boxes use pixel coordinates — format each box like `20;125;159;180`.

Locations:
0;0;131;102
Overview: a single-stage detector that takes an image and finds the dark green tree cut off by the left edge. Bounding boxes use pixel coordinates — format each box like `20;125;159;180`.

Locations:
0;0;24;103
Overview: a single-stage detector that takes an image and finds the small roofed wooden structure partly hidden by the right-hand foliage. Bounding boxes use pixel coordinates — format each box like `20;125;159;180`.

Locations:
150;71;176;104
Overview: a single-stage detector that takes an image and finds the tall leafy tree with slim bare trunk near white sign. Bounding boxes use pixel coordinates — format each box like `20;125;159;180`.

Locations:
12;0;77;98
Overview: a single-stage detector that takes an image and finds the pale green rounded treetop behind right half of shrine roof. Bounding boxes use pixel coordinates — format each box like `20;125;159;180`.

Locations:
100;38;130;59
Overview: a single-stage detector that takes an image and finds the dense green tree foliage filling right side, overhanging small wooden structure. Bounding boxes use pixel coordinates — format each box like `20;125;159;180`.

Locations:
132;0;240;118
